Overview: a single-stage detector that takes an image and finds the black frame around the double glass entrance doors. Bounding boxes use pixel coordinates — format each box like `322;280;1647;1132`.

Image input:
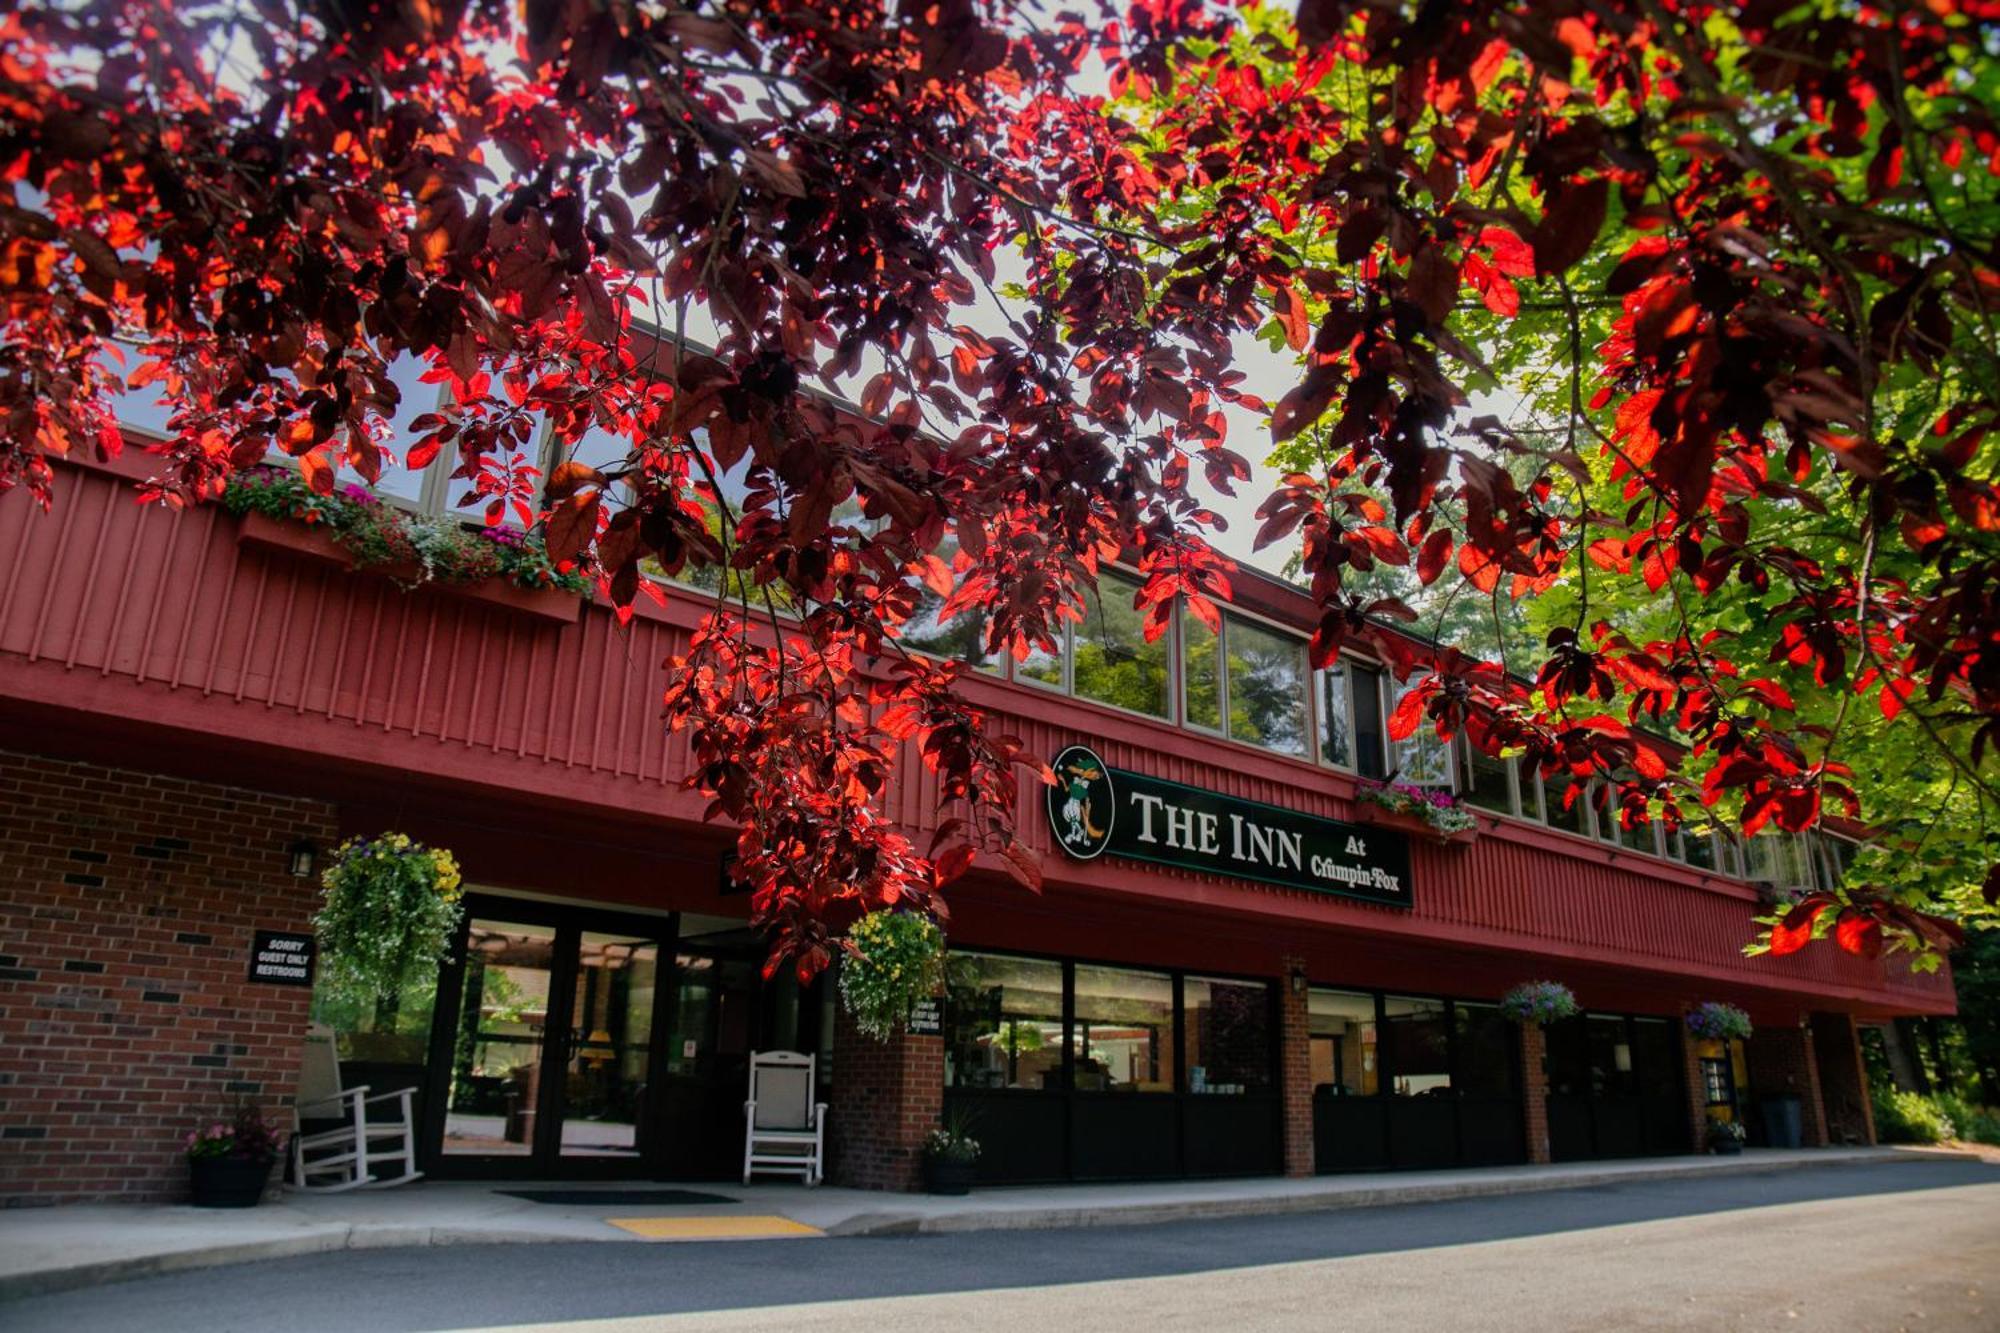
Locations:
418;893;680;1181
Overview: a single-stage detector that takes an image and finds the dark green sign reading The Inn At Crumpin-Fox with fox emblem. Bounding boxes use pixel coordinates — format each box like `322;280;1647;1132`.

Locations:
1048;745;1410;907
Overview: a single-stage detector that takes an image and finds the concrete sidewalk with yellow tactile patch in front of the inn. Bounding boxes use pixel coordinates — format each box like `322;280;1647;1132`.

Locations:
0;1149;1954;1299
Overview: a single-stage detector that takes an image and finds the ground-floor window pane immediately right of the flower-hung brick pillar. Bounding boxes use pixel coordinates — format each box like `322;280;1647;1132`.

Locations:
944;951;1062;1089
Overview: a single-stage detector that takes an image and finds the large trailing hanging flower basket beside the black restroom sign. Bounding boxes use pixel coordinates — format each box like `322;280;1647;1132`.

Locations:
312;833;464;1003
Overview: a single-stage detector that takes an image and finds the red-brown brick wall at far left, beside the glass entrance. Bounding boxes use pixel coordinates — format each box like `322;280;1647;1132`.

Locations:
0;753;334;1205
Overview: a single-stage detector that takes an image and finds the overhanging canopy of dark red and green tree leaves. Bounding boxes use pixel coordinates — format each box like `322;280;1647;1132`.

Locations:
0;0;2000;969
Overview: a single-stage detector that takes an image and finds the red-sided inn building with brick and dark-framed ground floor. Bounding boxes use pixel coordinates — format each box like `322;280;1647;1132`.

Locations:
0;460;1954;1201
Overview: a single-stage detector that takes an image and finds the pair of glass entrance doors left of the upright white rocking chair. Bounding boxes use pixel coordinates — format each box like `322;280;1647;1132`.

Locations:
426;903;672;1177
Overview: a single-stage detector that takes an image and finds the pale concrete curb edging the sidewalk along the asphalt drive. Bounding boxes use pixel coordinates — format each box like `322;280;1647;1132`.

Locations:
0;1149;1986;1301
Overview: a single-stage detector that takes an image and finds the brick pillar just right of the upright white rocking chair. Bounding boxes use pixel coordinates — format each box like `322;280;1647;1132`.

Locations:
826;1003;948;1191
